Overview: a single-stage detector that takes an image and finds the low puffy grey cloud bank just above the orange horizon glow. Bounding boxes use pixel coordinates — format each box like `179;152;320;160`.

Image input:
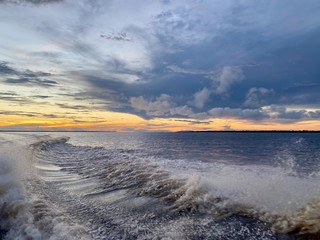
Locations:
129;91;320;122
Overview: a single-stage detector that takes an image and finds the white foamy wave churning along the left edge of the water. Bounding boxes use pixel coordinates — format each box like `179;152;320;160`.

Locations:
0;136;89;240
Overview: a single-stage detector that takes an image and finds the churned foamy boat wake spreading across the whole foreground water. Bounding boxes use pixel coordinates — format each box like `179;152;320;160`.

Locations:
0;134;320;239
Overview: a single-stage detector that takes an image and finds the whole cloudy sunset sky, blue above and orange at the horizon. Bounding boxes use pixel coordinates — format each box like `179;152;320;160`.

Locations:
0;0;320;131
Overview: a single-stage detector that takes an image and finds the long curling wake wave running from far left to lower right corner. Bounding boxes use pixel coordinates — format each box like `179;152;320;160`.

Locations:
34;138;320;238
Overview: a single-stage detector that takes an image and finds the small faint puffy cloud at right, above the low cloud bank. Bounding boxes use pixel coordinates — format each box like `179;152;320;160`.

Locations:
244;88;275;108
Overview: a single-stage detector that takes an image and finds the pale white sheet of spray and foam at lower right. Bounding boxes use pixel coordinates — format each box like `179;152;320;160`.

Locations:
172;165;320;236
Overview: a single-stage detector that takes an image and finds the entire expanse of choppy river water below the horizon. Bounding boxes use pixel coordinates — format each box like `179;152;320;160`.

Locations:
0;132;320;239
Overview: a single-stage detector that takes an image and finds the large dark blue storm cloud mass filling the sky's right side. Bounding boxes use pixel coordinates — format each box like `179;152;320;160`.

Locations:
81;29;320;121
